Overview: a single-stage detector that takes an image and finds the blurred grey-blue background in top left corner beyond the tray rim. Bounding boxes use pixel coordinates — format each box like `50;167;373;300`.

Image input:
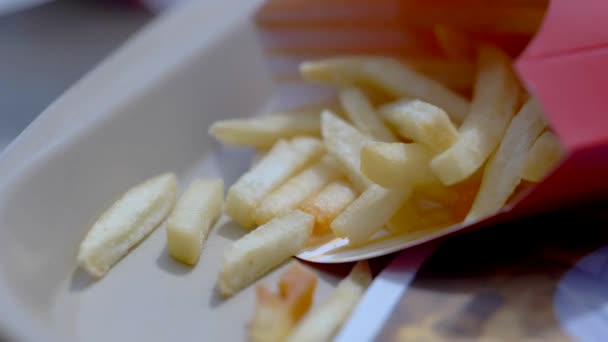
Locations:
0;0;166;152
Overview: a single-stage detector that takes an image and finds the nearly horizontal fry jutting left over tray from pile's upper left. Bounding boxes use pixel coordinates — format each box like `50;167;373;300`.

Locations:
209;109;321;148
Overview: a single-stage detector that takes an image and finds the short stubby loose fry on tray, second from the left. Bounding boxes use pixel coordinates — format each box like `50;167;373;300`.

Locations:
167;179;224;265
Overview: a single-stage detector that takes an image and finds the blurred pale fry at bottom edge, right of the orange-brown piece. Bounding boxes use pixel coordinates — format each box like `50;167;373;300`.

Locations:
287;261;372;342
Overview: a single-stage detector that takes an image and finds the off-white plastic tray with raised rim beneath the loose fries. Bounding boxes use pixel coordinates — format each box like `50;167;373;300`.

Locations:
0;0;344;342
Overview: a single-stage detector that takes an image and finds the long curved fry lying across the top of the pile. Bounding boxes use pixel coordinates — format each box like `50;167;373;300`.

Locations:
300;57;469;123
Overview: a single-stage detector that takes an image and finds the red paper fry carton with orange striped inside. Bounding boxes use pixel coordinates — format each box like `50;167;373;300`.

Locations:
256;0;608;240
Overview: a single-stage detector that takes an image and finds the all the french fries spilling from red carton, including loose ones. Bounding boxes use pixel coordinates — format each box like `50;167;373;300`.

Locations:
78;23;562;341
